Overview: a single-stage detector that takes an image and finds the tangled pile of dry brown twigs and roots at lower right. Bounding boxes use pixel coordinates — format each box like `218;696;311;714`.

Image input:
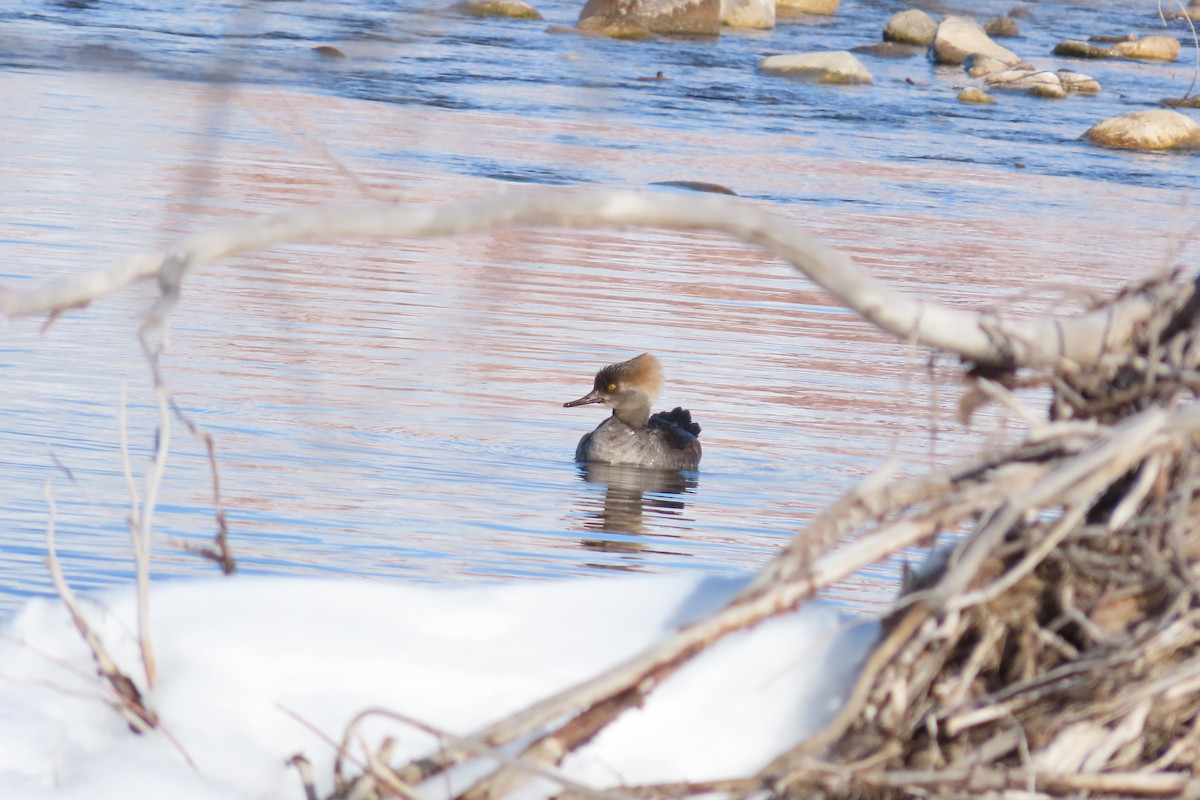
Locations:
763;276;1200;798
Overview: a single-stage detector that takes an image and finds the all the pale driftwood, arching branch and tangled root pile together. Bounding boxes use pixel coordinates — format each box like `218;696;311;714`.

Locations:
9;190;1200;800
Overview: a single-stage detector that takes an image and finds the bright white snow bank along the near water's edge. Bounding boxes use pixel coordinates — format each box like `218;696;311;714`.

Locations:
0;575;876;800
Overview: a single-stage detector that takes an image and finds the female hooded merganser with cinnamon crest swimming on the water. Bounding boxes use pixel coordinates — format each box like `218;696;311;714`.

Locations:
563;353;701;469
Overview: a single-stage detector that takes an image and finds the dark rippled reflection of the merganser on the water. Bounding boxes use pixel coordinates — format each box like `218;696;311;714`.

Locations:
580;463;698;553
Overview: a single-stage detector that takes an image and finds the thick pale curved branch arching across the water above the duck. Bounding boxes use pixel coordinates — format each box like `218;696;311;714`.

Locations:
0;188;1153;368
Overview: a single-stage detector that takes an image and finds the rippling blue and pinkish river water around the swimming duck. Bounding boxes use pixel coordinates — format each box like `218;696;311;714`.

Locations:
0;0;1200;613
